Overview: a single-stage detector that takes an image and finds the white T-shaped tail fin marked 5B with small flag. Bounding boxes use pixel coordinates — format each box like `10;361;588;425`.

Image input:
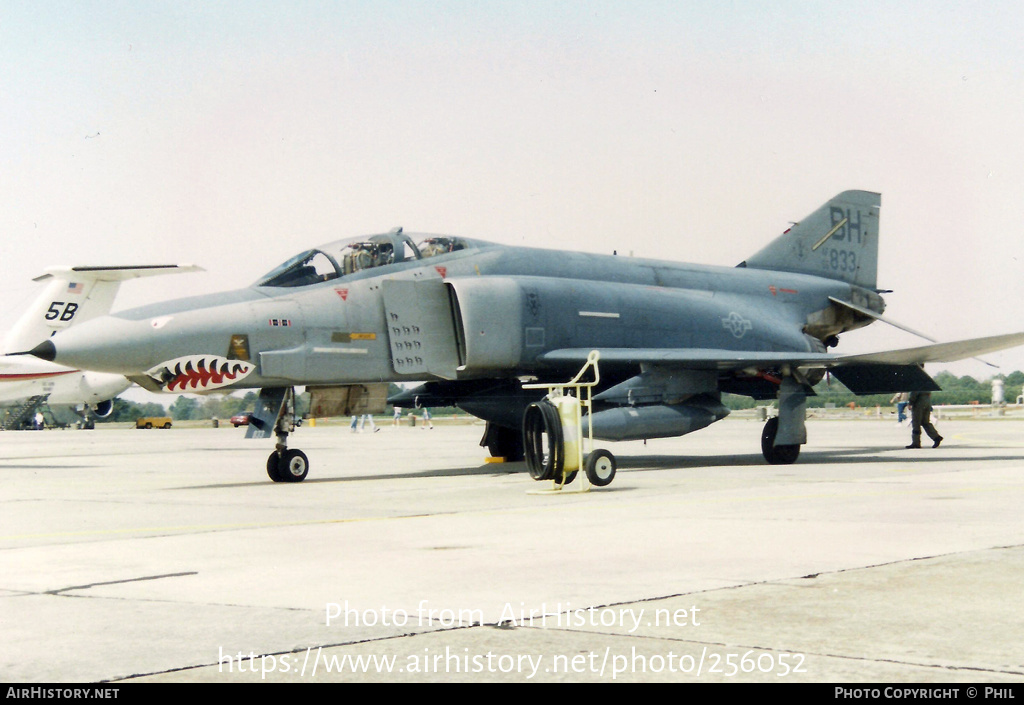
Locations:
5;264;202;351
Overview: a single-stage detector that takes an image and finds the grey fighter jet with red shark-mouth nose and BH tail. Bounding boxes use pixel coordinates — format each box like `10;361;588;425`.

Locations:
22;191;1024;482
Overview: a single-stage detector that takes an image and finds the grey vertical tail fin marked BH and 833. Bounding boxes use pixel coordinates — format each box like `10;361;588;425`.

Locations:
740;191;882;290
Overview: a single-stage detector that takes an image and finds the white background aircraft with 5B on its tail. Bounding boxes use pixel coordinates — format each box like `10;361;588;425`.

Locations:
0;265;201;428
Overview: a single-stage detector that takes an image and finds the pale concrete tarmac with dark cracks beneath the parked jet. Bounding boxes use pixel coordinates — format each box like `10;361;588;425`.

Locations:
0;418;1024;683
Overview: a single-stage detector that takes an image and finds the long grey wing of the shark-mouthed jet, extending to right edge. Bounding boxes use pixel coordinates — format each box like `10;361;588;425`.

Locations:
541;333;1024;371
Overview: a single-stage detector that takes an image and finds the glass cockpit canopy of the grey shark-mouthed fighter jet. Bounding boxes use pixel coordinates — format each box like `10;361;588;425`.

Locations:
256;227;468;287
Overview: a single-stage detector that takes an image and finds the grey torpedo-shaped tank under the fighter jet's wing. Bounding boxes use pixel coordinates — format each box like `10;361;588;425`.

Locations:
584;400;729;441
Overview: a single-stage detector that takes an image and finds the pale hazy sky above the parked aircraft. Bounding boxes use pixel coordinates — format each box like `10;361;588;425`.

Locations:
0;0;1024;395
